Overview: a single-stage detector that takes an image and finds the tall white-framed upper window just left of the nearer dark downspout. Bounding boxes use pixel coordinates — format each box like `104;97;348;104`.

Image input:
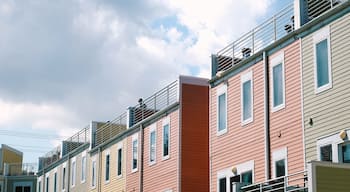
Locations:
241;71;253;125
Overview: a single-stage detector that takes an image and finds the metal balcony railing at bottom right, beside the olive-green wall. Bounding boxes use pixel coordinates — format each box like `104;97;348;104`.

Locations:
241;171;308;192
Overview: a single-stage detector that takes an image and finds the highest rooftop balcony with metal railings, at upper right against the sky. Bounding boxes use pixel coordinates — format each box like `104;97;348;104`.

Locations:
212;0;349;77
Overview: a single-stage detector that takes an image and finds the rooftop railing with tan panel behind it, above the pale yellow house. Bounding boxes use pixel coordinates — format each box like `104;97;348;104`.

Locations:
92;112;127;147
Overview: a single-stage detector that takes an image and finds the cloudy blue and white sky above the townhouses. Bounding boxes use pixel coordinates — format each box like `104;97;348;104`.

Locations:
0;0;293;162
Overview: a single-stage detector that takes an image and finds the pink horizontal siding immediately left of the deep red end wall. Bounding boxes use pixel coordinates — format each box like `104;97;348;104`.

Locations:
143;110;179;192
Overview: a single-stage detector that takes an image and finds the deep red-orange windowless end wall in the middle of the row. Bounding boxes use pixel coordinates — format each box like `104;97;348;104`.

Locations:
181;84;209;191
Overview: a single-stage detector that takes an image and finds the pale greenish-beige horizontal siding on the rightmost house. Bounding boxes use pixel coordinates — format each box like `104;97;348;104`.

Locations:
302;13;350;161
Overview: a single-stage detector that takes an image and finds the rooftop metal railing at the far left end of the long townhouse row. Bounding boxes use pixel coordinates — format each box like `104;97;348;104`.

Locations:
39;126;91;170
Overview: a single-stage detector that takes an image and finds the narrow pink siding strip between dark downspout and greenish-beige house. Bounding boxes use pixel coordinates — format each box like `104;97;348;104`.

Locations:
269;41;304;175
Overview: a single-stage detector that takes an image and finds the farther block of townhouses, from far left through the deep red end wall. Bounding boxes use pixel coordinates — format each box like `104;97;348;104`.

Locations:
37;76;209;192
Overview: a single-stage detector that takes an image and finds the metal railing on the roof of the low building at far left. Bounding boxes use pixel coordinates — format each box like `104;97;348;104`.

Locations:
3;163;38;176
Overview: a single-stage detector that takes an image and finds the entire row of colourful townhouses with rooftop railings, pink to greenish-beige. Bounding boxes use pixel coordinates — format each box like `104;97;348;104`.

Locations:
37;0;350;192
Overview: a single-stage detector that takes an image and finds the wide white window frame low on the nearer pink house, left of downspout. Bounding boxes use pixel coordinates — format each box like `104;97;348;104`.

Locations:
216;160;255;191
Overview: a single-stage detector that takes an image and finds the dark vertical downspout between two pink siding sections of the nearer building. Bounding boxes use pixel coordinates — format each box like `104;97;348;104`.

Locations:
263;51;271;180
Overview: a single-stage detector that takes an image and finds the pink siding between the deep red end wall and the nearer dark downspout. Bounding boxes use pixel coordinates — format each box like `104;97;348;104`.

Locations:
209;62;265;191
